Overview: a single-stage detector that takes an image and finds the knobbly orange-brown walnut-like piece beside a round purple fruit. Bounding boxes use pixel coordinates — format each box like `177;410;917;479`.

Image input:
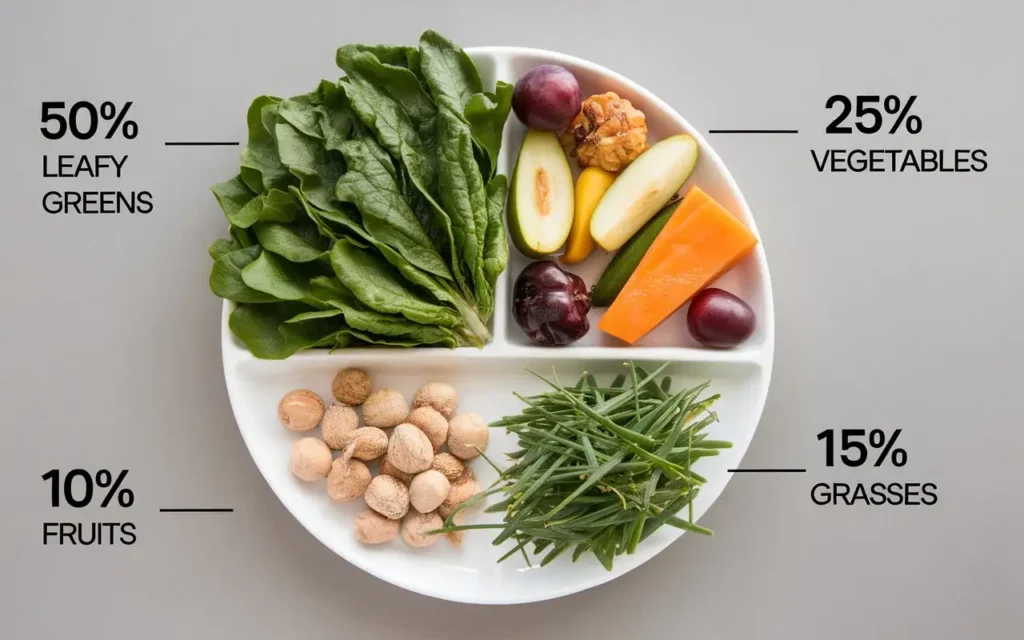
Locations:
559;91;647;173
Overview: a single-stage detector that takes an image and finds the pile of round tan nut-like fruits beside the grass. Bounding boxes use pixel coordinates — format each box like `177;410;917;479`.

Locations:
278;369;489;548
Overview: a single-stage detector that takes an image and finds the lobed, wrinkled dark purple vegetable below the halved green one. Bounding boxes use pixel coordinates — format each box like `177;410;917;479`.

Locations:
512;260;590;346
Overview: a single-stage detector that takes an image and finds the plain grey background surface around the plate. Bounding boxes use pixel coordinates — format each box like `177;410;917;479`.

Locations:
0;0;1024;640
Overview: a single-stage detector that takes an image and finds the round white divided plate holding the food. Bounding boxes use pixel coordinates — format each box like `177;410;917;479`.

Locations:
222;47;774;604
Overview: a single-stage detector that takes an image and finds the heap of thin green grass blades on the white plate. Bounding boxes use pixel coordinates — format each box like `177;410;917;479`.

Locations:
436;362;732;570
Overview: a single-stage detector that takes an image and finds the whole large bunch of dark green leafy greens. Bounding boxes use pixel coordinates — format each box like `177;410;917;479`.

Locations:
209;31;512;358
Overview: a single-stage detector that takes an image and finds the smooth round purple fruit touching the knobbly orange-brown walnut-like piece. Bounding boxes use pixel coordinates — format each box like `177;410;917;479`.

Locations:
512;65;581;131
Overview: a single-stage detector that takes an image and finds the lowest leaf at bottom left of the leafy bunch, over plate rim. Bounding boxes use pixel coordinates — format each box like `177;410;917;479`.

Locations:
227;302;339;359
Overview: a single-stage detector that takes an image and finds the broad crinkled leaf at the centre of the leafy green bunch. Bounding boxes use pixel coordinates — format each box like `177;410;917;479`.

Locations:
337;138;452;280
